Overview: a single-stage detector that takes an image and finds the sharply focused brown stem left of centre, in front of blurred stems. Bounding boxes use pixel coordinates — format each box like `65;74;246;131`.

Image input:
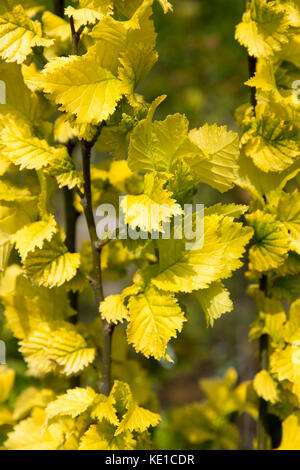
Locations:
81;141;114;395
